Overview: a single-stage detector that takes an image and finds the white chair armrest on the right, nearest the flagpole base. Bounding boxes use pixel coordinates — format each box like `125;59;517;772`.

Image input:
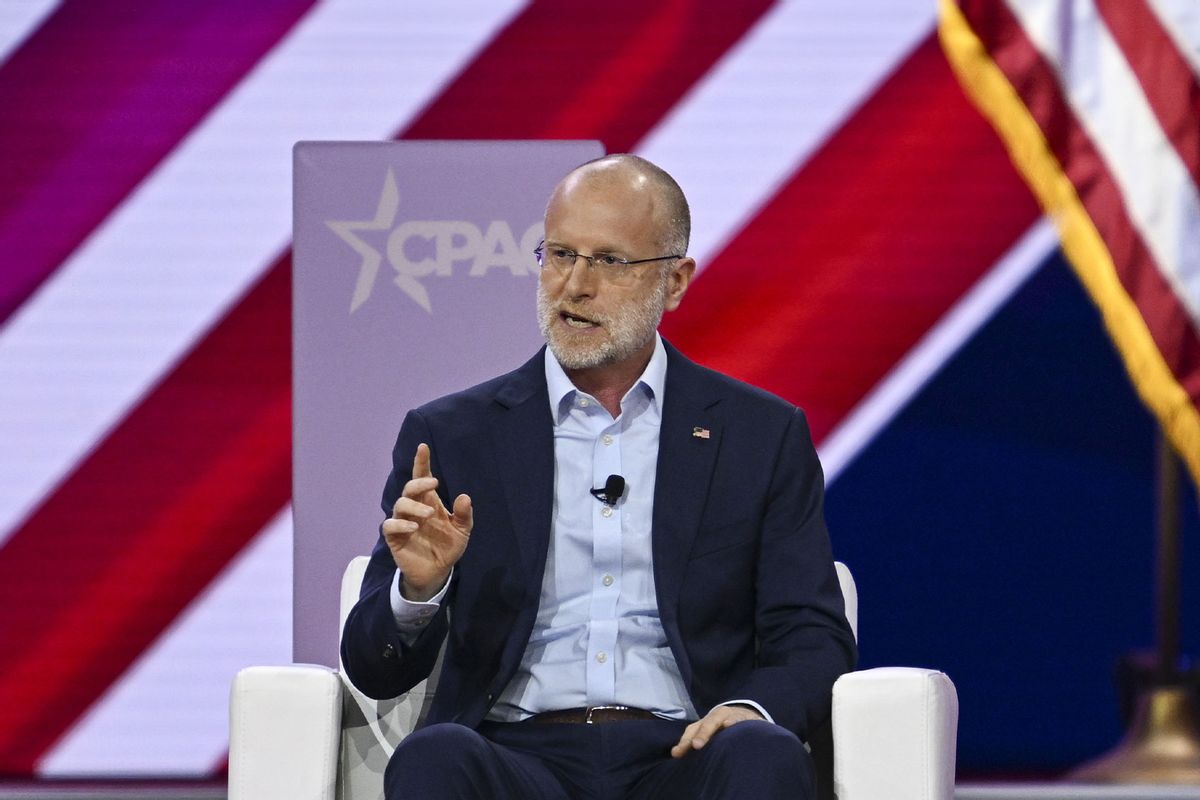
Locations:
833;667;959;800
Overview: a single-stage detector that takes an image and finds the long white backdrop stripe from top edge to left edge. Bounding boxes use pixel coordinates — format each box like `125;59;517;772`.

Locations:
0;0;518;542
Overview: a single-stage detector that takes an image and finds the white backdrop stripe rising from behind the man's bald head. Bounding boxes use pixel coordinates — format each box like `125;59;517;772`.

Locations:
636;0;936;269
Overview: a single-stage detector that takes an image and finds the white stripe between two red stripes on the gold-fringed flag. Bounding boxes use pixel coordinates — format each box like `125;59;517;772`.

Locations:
1008;0;1200;326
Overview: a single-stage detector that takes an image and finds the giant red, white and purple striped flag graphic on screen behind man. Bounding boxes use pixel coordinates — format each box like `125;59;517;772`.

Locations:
0;0;1198;777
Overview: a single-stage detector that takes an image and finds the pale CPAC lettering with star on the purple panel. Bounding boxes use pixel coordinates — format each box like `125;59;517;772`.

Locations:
325;168;541;314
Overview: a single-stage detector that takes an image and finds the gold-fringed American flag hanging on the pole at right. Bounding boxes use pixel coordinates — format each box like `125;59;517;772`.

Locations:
941;0;1200;483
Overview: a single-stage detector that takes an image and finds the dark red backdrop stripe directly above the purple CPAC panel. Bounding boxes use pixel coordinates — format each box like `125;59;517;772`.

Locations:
400;0;770;152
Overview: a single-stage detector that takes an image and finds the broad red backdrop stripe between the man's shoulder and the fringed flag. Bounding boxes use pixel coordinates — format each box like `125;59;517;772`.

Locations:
662;36;1038;440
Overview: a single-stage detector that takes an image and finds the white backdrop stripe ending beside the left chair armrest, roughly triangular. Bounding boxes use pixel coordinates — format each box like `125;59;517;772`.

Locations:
37;506;292;777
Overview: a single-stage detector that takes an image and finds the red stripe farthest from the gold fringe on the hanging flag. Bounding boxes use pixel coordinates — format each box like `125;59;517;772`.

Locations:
1096;0;1200;185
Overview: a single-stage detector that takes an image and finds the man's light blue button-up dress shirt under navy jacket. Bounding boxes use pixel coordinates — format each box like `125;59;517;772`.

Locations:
391;337;770;722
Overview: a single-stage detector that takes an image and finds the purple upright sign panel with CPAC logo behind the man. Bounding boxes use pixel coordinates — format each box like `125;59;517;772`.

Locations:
293;142;604;666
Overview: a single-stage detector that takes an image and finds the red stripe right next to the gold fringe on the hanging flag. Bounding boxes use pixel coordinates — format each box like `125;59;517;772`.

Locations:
961;0;1200;402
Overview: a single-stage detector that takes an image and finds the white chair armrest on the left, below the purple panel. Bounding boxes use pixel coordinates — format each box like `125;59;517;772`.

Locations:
229;664;342;800
